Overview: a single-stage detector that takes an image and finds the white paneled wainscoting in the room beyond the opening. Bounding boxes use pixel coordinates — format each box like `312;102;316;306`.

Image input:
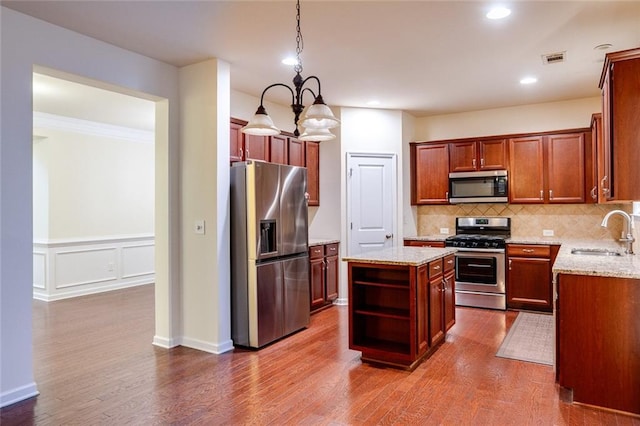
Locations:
33;235;155;301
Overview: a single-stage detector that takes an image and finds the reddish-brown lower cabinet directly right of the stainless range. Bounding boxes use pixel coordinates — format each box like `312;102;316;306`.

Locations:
506;244;559;312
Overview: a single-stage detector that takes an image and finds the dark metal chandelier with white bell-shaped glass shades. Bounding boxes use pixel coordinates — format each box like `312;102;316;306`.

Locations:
242;0;340;142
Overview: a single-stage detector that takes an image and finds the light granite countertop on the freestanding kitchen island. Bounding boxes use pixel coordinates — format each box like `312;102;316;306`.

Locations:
342;246;456;266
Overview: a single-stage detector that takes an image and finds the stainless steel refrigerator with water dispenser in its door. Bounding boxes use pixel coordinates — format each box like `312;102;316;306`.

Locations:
231;161;310;348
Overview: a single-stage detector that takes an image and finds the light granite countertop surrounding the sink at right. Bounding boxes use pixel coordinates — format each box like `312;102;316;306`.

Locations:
553;240;640;279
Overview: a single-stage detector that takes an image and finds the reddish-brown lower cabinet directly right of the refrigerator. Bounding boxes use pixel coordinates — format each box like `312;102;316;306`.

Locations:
309;243;340;313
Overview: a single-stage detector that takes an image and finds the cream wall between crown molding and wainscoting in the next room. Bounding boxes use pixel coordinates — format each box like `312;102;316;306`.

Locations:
33;129;155;240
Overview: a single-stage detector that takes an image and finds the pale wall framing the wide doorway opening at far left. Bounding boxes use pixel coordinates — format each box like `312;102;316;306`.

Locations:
0;7;180;406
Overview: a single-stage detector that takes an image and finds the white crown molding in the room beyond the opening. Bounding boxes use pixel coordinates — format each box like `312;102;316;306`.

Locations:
33;111;155;143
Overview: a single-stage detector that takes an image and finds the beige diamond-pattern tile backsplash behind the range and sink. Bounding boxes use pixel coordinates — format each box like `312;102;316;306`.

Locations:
418;204;631;239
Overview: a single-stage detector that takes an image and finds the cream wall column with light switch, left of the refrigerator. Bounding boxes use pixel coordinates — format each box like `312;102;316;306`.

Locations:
180;59;233;353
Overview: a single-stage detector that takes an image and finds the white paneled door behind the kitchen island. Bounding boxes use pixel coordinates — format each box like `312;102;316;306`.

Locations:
347;154;397;255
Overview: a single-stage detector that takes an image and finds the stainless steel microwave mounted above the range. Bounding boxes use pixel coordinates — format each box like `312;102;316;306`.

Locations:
449;170;509;204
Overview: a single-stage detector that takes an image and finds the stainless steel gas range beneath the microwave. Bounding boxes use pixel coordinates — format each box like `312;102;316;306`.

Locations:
445;217;511;310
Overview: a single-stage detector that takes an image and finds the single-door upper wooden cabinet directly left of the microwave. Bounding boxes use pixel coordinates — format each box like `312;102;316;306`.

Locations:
411;143;449;205
